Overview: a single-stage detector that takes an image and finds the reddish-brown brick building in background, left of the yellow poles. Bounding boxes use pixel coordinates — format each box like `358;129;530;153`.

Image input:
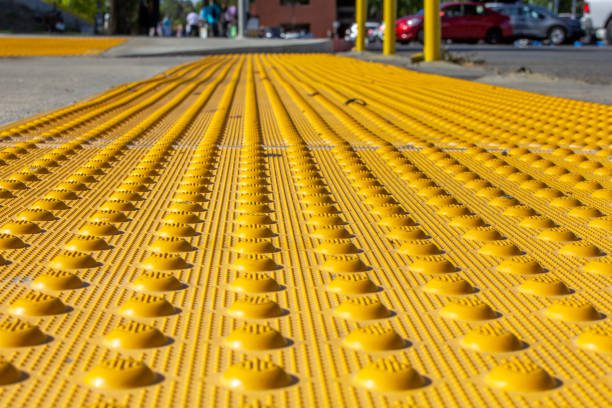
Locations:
251;0;355;37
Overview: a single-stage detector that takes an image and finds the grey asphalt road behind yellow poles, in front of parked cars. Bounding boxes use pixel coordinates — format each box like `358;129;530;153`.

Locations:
371;44;612;85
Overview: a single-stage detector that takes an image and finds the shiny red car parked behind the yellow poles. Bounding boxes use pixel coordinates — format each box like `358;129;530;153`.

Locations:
395;3;512;44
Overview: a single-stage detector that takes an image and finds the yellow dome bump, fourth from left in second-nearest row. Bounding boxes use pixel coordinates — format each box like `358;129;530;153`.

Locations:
342;324;406;352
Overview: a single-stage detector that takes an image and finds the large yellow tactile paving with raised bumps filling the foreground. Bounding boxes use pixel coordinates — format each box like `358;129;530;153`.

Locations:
0;55;612;407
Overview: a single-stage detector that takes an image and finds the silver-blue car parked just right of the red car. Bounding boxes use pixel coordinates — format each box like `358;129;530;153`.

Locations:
486;3;581;45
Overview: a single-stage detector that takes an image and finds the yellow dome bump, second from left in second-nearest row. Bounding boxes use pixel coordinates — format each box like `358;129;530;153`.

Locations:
104;321;168;349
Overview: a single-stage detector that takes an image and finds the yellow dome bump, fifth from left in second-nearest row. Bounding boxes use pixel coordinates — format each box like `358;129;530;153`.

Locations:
460;326;524;353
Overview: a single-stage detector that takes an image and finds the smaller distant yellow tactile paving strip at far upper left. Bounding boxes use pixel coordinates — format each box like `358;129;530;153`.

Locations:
0;36;126;57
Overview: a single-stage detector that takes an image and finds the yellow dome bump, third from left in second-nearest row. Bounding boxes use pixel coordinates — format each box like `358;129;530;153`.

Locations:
225;323;288;351
